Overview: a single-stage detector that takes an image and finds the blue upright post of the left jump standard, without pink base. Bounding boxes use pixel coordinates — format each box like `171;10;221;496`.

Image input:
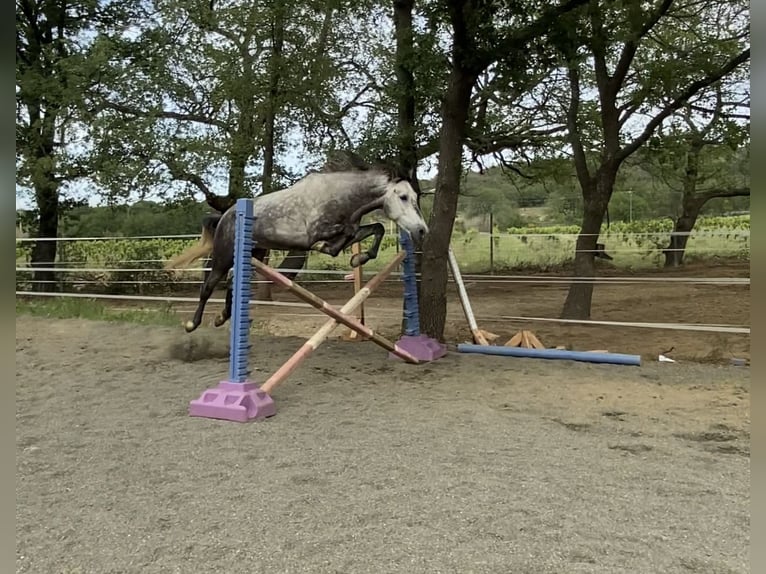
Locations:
229;199;253;383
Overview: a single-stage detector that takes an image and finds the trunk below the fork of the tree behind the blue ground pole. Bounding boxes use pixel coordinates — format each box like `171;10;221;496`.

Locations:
561;179;617;319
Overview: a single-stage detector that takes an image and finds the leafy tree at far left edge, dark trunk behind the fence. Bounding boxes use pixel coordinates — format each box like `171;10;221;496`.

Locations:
16;0;140;291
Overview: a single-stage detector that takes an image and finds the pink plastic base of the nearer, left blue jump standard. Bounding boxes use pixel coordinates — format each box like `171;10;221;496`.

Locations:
189;381;277;423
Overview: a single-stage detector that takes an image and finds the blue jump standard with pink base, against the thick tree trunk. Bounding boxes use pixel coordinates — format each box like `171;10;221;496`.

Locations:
389;230;447;362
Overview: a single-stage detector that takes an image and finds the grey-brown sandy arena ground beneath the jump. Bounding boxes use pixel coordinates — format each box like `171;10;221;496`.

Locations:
16;306;750;574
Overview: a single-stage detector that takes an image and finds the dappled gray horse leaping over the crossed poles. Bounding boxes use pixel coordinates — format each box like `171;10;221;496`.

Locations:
166;163;428;333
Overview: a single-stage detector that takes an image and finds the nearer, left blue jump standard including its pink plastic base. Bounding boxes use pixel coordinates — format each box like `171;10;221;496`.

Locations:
189;199;276;422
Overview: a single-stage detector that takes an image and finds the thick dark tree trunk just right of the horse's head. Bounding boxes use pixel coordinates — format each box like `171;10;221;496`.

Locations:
420;66;476;340
